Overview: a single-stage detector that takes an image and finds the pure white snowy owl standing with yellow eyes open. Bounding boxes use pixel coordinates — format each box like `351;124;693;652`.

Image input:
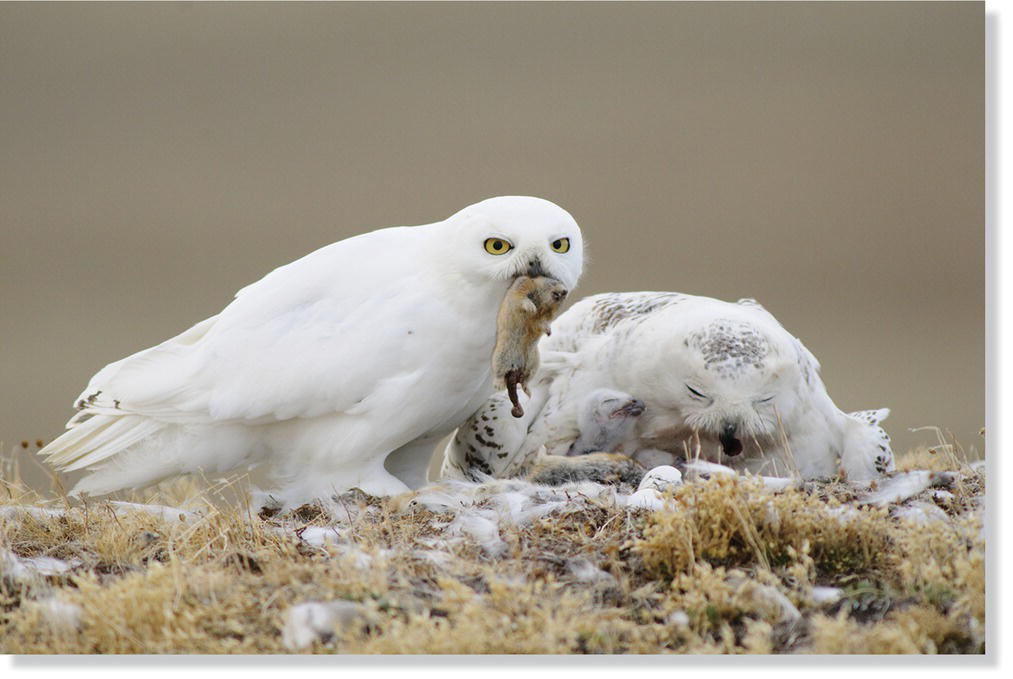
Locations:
42;197;582;506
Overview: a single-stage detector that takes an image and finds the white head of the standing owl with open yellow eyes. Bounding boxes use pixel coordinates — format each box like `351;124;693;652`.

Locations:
445;196;583;290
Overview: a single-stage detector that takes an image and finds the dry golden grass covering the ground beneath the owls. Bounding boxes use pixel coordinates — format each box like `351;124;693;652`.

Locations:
0;451;985;654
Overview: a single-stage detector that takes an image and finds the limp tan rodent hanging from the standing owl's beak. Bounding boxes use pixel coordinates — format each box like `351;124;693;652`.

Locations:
492;276;567;418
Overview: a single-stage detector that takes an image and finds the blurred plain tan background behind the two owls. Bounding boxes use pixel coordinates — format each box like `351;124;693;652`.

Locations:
0;3;985;490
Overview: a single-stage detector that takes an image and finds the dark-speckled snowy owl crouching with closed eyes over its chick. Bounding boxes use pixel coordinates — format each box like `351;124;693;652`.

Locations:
445;292;893;480
